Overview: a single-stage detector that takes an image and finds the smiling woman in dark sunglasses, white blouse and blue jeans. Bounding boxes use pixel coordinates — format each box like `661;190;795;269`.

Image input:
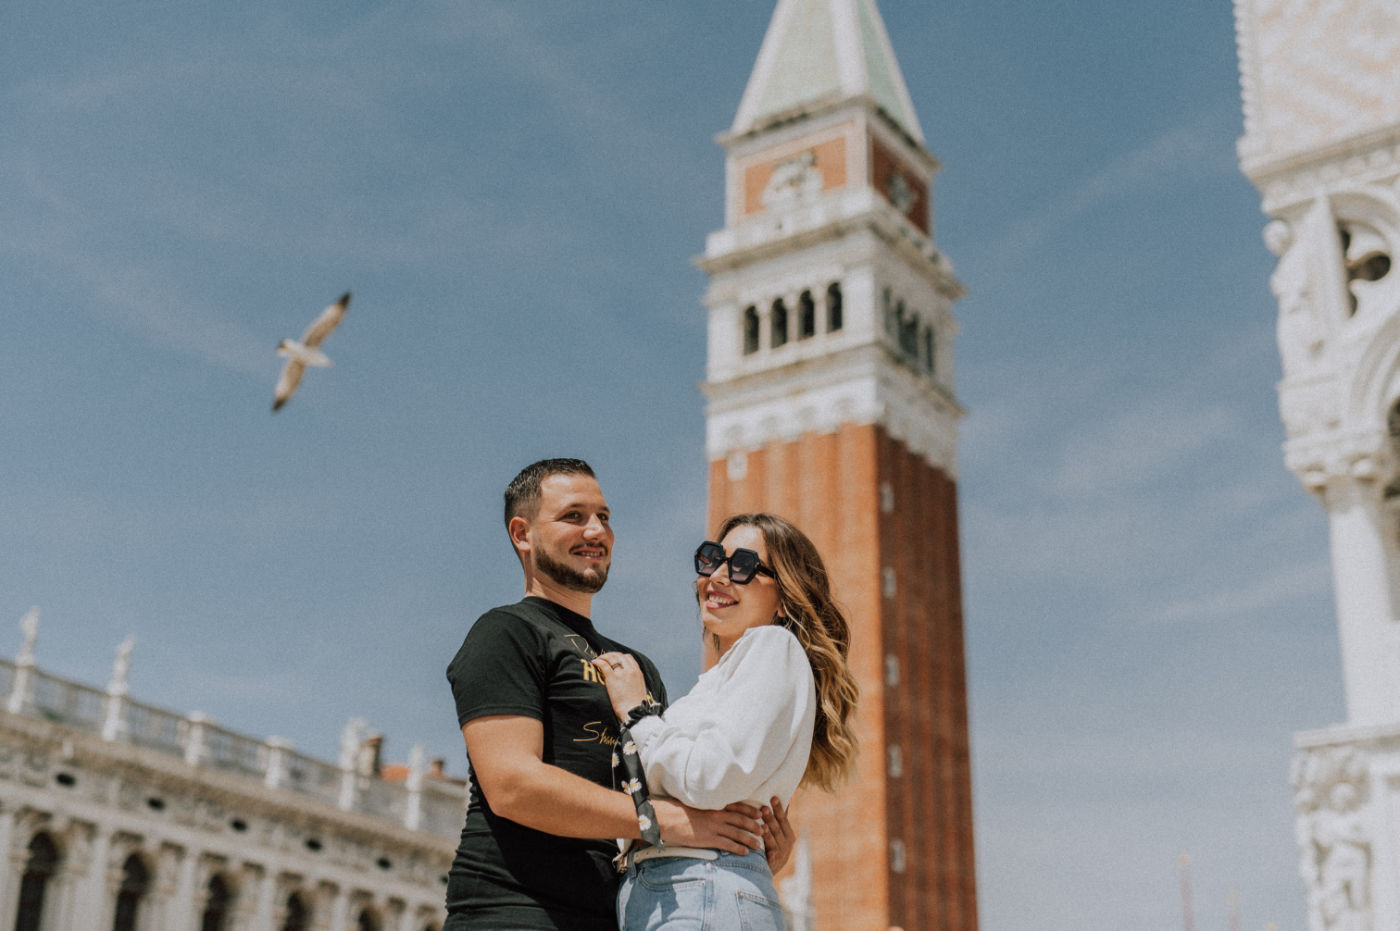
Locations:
595;514;858;931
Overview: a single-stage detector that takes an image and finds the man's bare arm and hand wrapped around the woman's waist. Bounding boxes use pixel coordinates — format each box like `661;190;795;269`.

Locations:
462;714;763;854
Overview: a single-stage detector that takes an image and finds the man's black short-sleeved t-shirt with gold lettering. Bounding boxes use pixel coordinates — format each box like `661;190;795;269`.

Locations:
447;596;666;931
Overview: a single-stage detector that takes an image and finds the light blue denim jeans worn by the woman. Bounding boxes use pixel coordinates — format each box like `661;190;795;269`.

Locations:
617;850;785;931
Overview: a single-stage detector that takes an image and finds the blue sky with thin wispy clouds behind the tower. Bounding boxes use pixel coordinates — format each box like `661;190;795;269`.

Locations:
0;0;1344;931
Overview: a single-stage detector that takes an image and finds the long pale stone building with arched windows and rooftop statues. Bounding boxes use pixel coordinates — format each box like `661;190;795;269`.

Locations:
0;610;465;931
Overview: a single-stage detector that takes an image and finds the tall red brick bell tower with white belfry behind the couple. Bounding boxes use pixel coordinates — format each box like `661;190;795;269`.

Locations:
699;0;977;931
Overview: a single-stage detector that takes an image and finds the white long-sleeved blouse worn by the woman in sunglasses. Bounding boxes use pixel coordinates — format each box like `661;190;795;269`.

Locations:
631;626;816;808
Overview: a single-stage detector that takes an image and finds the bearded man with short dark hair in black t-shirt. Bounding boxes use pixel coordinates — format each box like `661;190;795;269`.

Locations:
444;459;764;931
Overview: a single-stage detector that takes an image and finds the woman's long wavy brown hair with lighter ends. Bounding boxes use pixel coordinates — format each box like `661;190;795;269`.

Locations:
714;514;861;791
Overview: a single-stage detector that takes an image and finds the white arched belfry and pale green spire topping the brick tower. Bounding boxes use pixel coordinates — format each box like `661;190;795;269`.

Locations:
699;0;963;475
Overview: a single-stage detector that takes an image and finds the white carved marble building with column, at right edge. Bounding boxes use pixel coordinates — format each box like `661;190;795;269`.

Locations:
1235;0;1400;931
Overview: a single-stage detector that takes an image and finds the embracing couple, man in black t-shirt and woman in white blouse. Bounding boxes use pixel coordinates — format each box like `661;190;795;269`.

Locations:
444;459;858;931
